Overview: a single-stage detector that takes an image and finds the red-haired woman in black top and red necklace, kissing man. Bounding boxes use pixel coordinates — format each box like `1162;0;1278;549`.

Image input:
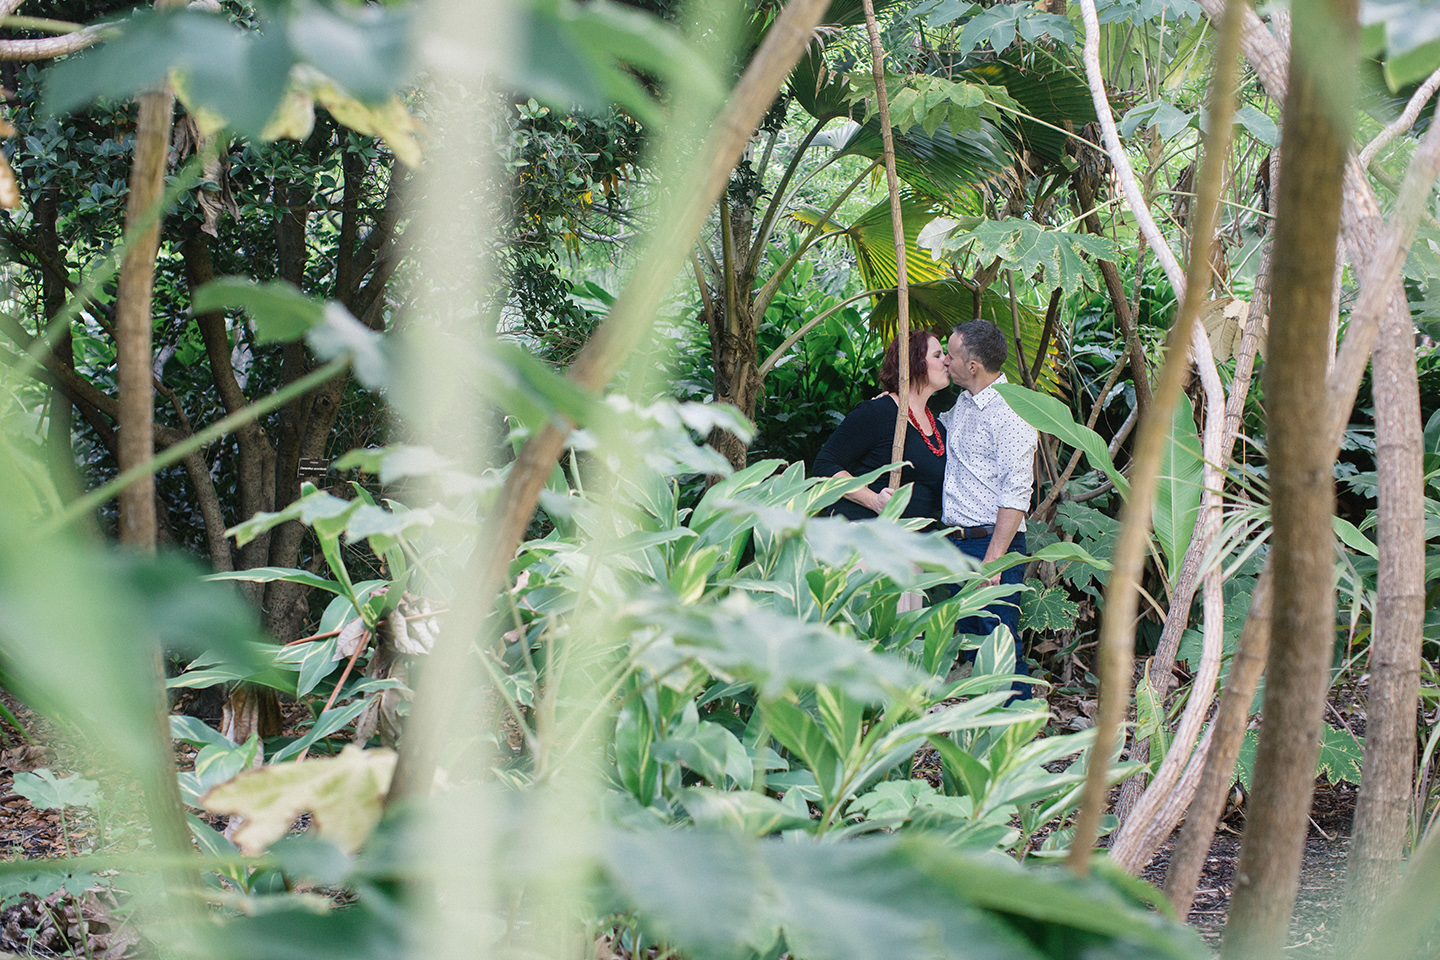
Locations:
815;330;950;521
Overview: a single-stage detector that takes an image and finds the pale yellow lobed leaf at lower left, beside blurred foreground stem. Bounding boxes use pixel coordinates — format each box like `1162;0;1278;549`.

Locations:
200;746;396;856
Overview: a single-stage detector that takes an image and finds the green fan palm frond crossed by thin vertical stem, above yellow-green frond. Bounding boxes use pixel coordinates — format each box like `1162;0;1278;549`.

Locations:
838;118;1009;199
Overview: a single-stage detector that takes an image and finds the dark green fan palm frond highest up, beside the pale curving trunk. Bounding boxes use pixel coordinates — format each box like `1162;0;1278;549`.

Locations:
965;50;1094;163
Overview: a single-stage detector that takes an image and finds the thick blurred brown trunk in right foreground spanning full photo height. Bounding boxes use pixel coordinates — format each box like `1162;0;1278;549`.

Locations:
1221;0;1358;959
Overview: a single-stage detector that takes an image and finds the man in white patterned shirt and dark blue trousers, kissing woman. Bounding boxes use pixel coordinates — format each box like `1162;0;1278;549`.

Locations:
940;320;1040;697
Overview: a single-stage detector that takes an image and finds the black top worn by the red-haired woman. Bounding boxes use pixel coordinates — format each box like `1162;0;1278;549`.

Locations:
814;396;945;520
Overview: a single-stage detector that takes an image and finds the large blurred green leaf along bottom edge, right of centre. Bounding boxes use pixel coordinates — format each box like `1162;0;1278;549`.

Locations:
602;830;1205;960
